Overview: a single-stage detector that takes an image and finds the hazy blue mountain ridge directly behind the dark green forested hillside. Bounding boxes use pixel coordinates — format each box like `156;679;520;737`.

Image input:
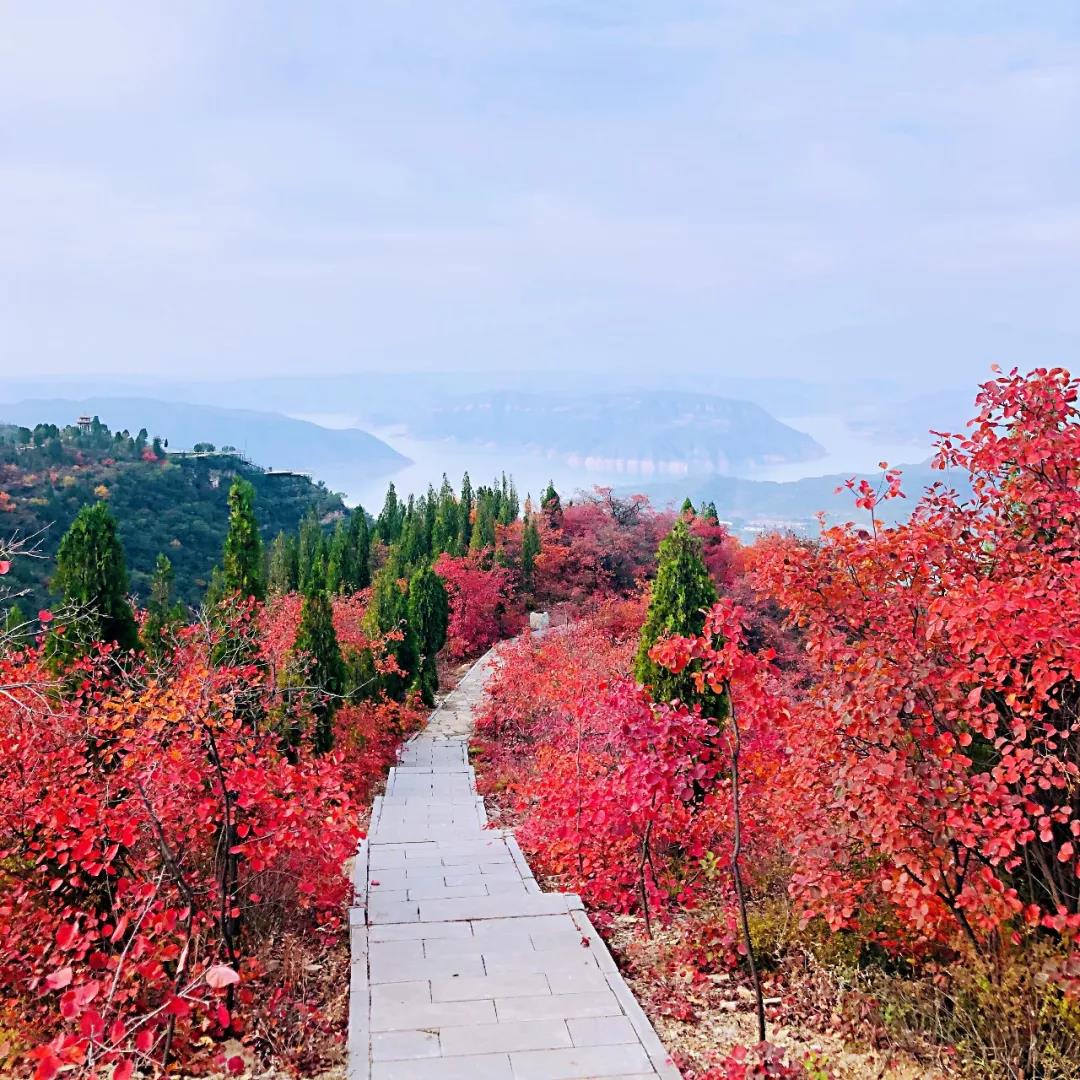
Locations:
0;396;408;486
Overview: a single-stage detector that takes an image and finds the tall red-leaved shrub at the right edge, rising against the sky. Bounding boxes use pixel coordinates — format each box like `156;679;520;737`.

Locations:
759;369;1080;948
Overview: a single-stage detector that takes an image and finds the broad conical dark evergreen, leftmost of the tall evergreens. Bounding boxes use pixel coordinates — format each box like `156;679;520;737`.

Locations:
49;502;138;662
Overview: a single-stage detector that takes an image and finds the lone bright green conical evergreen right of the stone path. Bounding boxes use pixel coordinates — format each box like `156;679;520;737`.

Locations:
634;517;726;719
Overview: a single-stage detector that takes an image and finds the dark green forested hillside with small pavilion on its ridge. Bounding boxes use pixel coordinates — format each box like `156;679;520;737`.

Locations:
0;423;345;611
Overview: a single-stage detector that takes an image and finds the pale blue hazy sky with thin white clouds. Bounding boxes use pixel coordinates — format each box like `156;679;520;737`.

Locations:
0;0;1080;382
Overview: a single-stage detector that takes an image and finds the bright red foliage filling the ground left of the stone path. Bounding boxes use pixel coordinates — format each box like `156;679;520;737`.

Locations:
0;600;425;1078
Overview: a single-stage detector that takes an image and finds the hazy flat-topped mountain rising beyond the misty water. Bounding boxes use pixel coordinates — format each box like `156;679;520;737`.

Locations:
407;391;825;477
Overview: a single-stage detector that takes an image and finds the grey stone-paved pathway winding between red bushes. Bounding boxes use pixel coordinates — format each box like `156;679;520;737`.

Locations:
349;654;679;1080
